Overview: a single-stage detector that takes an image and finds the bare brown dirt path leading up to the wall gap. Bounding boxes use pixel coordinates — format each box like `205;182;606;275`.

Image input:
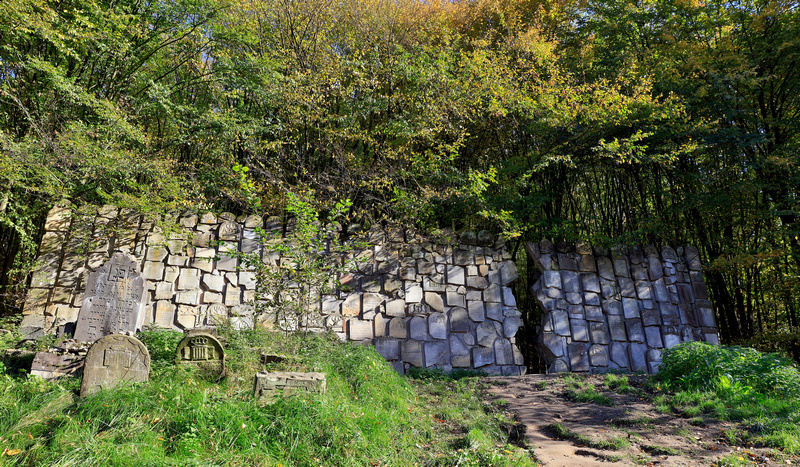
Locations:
487;375;800;467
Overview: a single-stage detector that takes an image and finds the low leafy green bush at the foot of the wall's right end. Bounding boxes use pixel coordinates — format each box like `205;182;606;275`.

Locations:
659;342;800;397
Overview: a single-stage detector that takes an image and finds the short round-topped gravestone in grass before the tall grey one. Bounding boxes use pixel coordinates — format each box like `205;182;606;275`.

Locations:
81;334;150;397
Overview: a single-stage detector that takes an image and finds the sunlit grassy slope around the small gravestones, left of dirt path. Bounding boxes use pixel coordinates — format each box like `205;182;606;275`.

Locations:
0;331;533;466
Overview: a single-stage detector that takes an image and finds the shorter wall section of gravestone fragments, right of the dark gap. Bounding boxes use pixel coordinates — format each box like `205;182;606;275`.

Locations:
526;240;719;373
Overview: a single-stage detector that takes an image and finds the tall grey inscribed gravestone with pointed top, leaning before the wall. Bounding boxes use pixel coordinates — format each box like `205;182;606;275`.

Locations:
75;251;147;342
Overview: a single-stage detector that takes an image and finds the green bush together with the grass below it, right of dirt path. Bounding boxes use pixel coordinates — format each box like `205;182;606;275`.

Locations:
658;342;800;454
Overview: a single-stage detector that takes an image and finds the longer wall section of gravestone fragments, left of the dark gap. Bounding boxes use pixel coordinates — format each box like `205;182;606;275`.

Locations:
22;206;525;374
